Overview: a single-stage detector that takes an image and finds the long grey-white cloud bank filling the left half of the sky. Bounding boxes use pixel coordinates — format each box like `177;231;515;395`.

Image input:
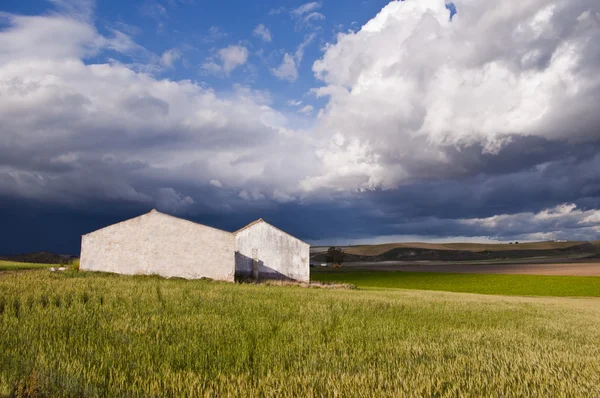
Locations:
0;9;314;211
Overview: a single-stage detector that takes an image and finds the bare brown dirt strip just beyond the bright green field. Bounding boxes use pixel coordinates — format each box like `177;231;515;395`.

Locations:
352;262;600;276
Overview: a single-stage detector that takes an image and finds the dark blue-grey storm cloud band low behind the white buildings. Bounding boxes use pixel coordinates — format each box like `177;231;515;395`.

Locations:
0;141;600;253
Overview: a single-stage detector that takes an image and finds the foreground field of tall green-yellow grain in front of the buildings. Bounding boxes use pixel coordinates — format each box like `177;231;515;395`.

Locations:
0;270;600;397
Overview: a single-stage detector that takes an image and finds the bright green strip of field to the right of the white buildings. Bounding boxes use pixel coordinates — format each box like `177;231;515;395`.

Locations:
311;269;600;297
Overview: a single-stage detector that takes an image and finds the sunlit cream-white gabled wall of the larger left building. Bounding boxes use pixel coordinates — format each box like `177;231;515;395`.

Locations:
80;210;235;281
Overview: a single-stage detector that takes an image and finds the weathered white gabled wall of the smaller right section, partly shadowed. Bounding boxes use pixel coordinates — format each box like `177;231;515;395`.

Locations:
235;221;310;282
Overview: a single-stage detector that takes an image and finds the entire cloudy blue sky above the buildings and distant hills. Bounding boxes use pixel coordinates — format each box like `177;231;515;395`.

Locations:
0;0;600;254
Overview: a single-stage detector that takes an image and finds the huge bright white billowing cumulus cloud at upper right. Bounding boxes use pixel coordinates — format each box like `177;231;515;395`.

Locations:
303;0;600;193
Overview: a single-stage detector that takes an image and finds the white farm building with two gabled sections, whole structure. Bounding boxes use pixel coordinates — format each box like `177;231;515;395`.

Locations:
80;210;310;282
